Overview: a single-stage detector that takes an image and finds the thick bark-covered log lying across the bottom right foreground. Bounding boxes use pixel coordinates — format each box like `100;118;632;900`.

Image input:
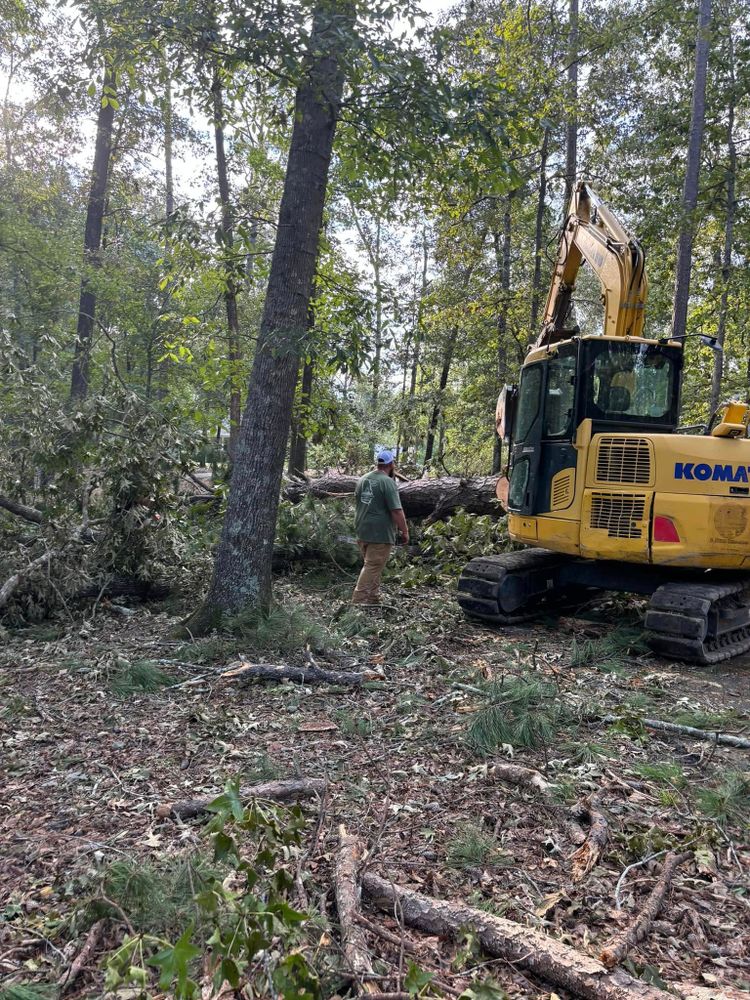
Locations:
362;872;674;1000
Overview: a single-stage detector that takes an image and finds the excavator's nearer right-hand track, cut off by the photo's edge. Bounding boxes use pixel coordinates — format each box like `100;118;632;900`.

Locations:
646;578;750;664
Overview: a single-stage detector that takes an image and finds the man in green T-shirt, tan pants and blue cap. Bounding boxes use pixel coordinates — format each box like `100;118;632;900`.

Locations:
352;451;409;604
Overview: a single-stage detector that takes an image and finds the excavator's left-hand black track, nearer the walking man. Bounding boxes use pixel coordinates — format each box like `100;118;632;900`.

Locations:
458;549;582;625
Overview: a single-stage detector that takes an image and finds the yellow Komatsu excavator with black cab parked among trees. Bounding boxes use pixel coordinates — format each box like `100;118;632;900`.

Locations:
458;183;750;664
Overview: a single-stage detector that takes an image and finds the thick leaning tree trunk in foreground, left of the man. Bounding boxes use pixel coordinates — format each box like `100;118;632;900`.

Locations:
188;3;352;631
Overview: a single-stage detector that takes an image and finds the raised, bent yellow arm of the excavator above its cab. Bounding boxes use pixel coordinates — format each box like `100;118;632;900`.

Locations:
533;182;648;347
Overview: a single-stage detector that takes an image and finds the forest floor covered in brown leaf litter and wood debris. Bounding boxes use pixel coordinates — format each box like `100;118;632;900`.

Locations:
0;577;750;998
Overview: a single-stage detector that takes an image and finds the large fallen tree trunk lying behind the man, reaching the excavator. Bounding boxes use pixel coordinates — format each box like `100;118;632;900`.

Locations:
282;472;505;520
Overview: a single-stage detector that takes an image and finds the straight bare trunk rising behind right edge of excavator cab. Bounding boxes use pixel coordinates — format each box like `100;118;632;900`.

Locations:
672;0;711;338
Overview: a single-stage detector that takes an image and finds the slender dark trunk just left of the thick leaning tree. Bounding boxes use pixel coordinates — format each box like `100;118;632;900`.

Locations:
211;63;242;466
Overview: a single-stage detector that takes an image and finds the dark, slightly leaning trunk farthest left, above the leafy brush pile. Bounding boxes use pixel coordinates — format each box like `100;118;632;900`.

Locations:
70;68;115;400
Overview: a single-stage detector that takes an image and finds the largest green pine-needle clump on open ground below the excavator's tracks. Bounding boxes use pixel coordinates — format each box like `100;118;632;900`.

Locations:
466;677;572;754
